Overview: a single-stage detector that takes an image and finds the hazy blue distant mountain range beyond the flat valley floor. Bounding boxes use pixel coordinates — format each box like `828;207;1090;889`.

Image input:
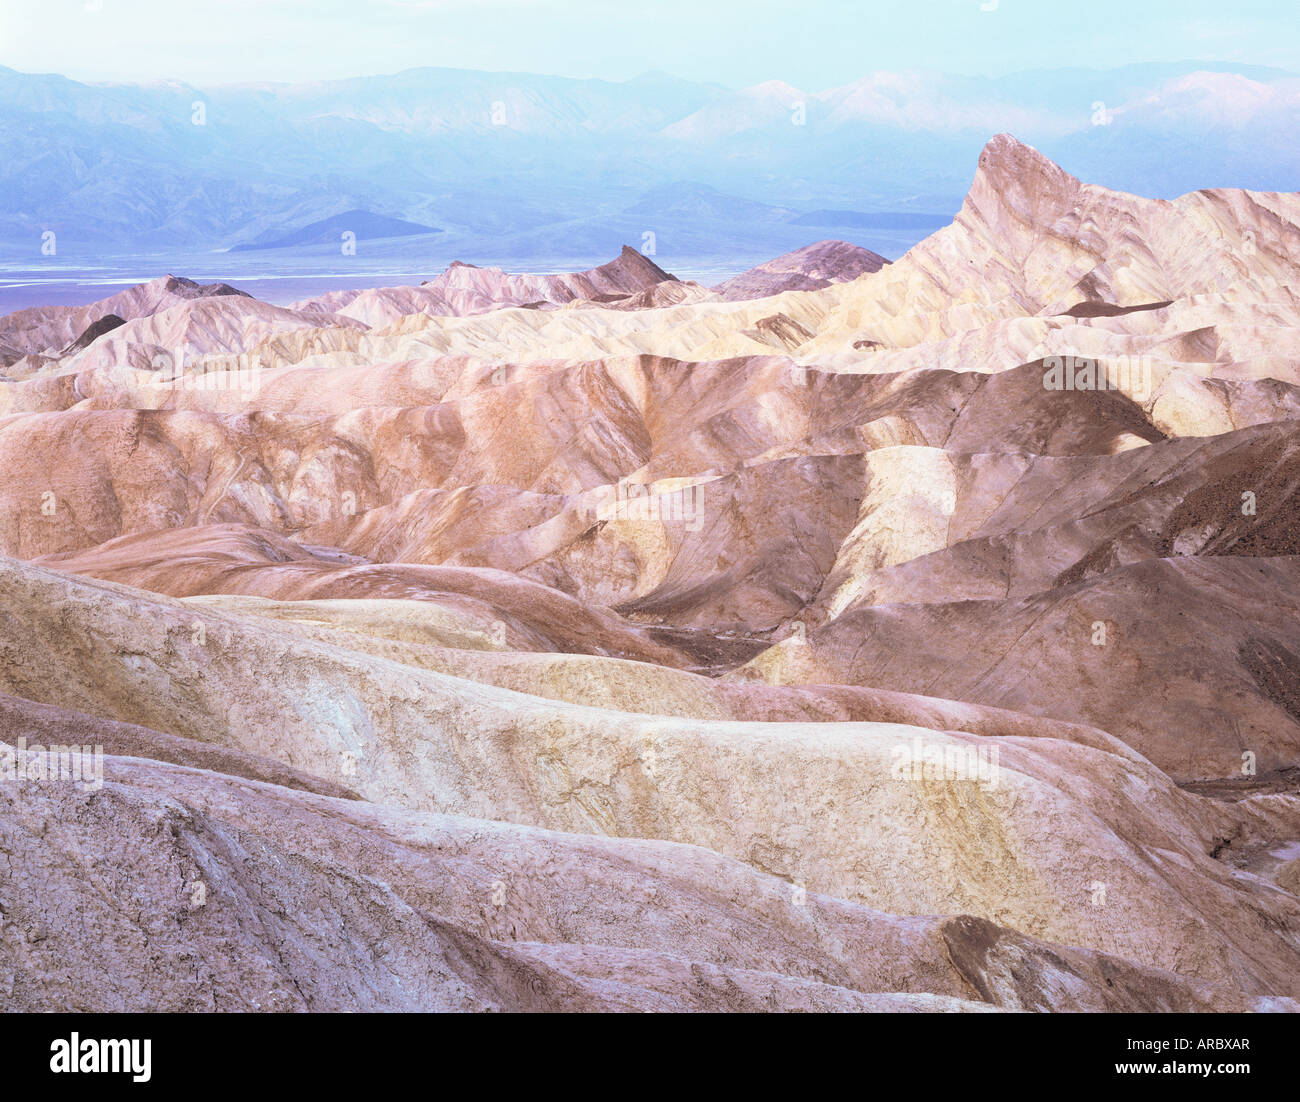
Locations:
0;62;1300;263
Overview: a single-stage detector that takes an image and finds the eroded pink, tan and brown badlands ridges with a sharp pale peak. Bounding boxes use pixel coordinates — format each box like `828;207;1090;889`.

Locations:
0;135;1300;1011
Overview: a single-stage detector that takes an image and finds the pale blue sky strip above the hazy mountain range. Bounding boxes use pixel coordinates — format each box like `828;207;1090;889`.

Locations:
0;0;1300;91
